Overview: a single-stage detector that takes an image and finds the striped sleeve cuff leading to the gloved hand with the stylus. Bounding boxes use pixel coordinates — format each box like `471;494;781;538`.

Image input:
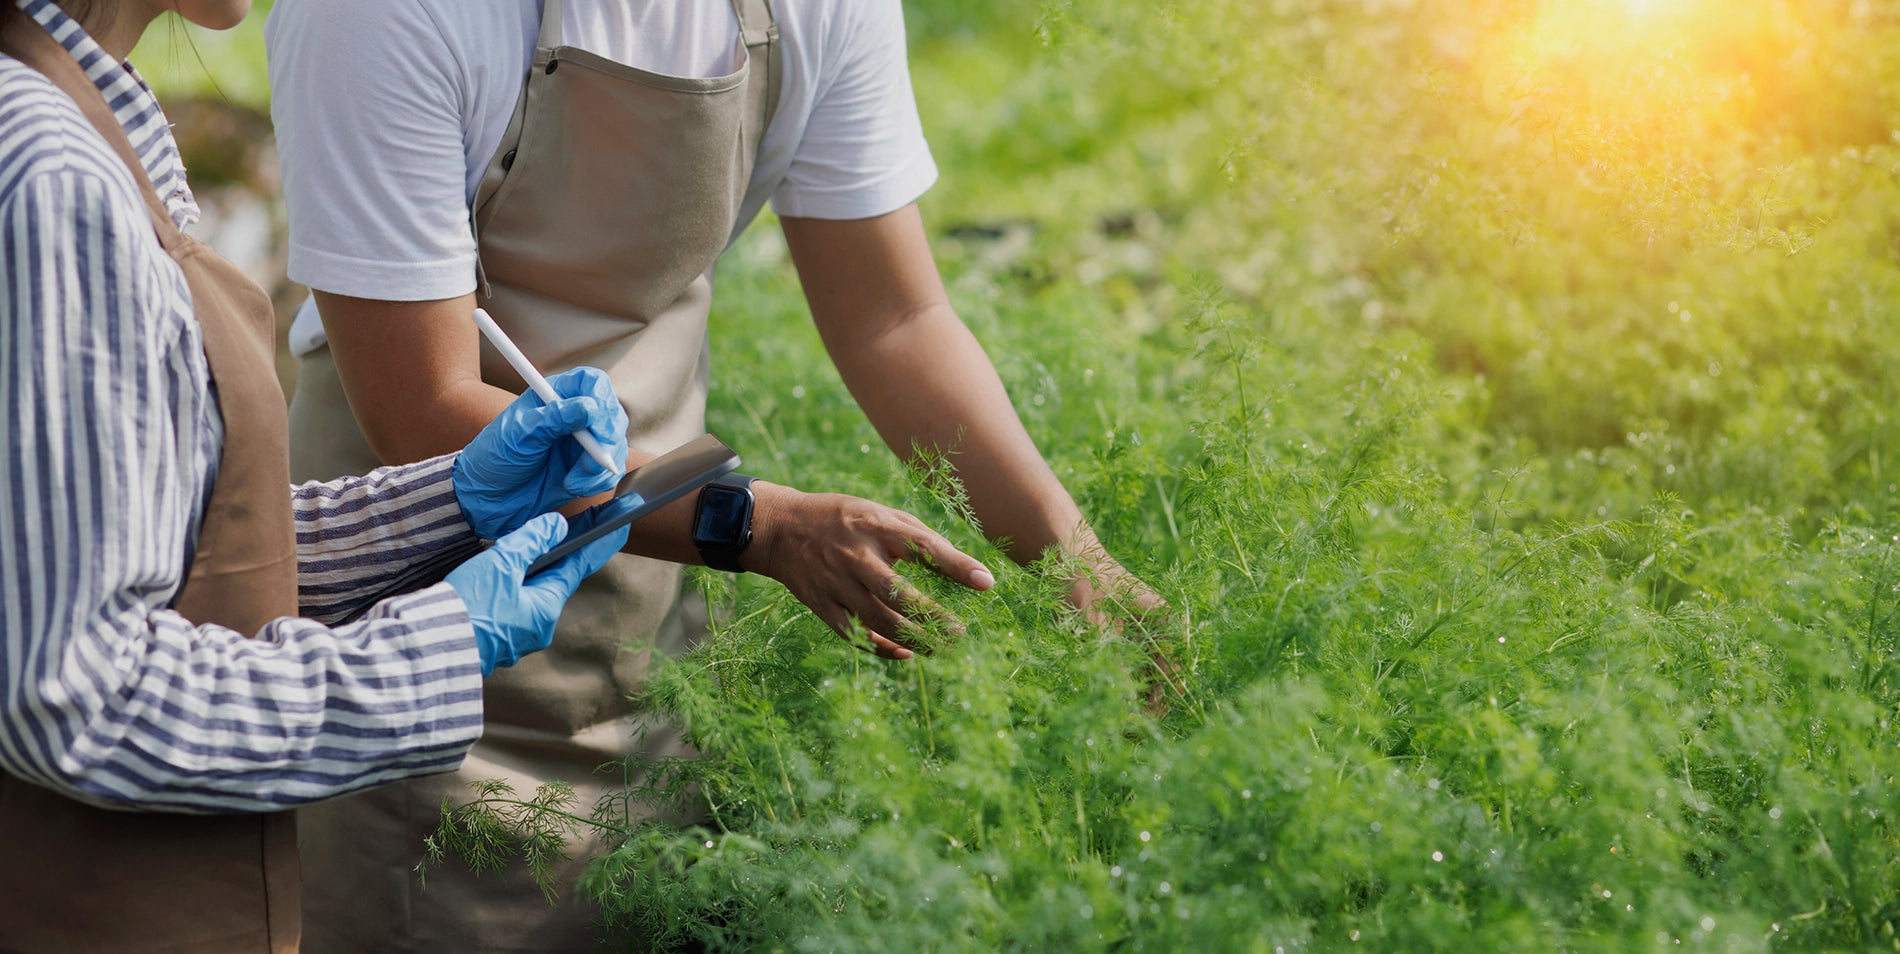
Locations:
293;454;475;620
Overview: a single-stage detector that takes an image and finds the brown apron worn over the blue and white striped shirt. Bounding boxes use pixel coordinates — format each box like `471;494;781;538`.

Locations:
0;9;300;954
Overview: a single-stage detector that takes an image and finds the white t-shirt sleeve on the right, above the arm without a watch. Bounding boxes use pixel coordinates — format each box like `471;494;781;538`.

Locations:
771;0;937;219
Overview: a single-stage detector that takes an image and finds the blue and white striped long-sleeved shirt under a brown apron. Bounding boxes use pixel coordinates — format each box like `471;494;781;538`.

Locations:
0;0;483;813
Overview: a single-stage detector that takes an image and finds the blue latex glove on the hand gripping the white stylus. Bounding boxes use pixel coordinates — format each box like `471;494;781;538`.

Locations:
454;367;627;540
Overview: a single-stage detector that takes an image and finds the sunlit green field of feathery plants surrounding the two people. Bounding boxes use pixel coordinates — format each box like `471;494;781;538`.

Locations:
135;0;1900;954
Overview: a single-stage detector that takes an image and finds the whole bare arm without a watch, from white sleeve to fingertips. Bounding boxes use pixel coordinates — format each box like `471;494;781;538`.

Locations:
781;205;1159;608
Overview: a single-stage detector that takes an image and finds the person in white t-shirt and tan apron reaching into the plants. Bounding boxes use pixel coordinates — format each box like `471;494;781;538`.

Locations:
266;0;1161;954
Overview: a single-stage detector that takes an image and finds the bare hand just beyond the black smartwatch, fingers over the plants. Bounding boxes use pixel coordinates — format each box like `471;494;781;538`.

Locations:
739;481;996;659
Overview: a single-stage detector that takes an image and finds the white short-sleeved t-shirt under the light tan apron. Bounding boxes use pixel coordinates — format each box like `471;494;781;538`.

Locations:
264;0;937;355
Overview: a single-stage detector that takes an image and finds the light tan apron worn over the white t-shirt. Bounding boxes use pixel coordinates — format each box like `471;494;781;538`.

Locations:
291;0;779;954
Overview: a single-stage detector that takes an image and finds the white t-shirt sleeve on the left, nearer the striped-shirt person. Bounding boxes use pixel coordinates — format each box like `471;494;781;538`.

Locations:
264;0;475;302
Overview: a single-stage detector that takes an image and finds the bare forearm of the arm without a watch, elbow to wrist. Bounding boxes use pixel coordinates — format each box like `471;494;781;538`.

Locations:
825;302;1096;563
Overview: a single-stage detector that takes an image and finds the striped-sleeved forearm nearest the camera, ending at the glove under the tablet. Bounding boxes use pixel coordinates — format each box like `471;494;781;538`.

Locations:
0;585;481;813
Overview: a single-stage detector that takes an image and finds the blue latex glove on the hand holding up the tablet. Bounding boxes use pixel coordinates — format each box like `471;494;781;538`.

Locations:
447;513;627;677
